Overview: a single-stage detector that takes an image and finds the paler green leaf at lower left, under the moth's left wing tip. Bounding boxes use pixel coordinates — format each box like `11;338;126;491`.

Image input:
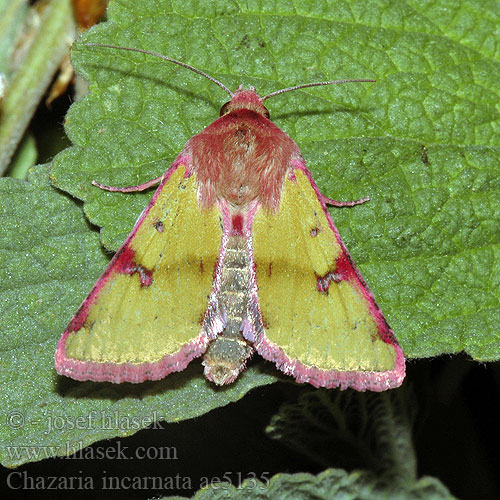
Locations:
0;167;275;467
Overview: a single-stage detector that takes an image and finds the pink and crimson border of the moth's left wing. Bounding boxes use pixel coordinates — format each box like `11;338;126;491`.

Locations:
55;155;209;384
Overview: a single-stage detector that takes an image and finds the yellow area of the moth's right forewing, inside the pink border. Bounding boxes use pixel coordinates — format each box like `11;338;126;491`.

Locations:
253;169;396;371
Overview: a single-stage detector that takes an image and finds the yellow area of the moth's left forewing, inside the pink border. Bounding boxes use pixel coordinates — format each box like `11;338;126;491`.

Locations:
66;165;222;364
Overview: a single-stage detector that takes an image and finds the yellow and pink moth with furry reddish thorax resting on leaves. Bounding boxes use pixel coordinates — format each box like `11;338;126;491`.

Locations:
55;44;405;391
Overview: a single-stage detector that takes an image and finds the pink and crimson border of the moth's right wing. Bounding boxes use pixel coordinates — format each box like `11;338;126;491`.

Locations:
249;160;406;392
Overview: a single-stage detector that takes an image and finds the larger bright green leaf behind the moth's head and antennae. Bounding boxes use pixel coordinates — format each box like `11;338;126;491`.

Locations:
51;0;500;360
